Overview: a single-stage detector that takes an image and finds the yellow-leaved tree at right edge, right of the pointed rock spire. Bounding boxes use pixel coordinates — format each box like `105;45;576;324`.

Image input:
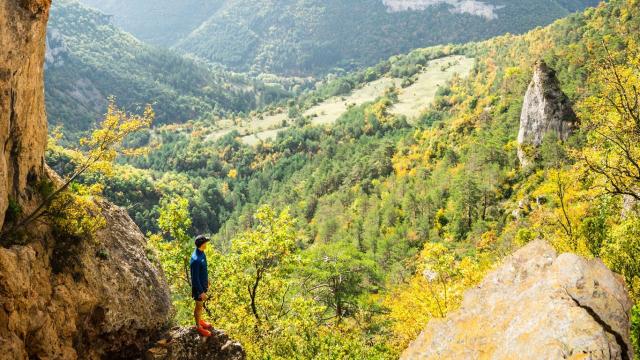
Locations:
575;37;640;201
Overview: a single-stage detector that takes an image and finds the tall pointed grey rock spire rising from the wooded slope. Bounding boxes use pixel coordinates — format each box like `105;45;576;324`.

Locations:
518;61;578;167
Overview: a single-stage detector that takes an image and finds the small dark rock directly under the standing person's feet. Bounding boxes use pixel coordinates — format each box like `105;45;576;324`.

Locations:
145;327;246;360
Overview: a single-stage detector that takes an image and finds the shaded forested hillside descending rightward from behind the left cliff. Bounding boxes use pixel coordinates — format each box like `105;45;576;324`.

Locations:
45;1;288;135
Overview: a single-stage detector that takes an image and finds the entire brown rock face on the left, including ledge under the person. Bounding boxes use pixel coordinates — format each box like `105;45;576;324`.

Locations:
0;0;244;360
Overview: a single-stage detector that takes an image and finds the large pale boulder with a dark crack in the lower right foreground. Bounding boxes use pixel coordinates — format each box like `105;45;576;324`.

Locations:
402;240;633;359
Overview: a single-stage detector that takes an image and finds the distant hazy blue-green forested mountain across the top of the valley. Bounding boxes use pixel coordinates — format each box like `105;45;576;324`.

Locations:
77;0;598;75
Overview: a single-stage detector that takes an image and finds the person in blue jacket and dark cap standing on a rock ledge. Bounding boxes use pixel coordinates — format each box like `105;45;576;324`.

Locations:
189;235;211;336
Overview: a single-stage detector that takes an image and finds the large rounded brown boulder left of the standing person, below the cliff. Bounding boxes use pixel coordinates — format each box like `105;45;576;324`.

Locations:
0;198;170;359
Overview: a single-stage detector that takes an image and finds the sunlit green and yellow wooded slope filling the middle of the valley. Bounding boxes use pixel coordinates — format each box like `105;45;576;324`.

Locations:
47;0;640;359
